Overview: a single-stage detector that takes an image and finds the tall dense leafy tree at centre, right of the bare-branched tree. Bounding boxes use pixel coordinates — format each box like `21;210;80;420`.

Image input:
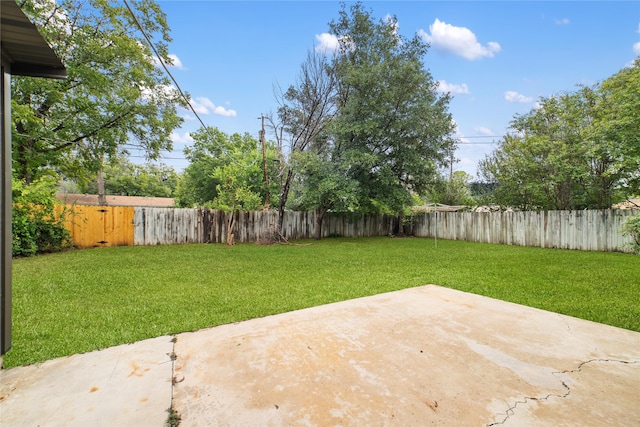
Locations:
329;3;454;214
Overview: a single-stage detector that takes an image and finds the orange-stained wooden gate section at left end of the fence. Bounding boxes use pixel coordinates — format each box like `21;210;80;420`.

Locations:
66;205;134;248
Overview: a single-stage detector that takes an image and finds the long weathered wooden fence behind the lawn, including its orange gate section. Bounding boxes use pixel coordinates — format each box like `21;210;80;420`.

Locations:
61;206;640;251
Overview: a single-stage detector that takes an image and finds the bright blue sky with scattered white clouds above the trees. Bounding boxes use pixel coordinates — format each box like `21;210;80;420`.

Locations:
146;0;640;176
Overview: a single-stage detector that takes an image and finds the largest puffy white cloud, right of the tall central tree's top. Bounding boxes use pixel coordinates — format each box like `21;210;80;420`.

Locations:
418;18;502;61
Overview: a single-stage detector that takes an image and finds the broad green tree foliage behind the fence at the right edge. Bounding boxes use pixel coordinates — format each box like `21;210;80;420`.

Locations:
479;61;640;210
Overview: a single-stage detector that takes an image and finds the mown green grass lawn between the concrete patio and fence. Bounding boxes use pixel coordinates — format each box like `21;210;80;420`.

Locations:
4;238;640;367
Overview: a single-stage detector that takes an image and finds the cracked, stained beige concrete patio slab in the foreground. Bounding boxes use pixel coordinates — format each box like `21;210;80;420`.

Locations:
0;285;640;426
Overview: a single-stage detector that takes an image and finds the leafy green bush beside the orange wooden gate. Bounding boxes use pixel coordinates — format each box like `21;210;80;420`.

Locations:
11;177;71;256
